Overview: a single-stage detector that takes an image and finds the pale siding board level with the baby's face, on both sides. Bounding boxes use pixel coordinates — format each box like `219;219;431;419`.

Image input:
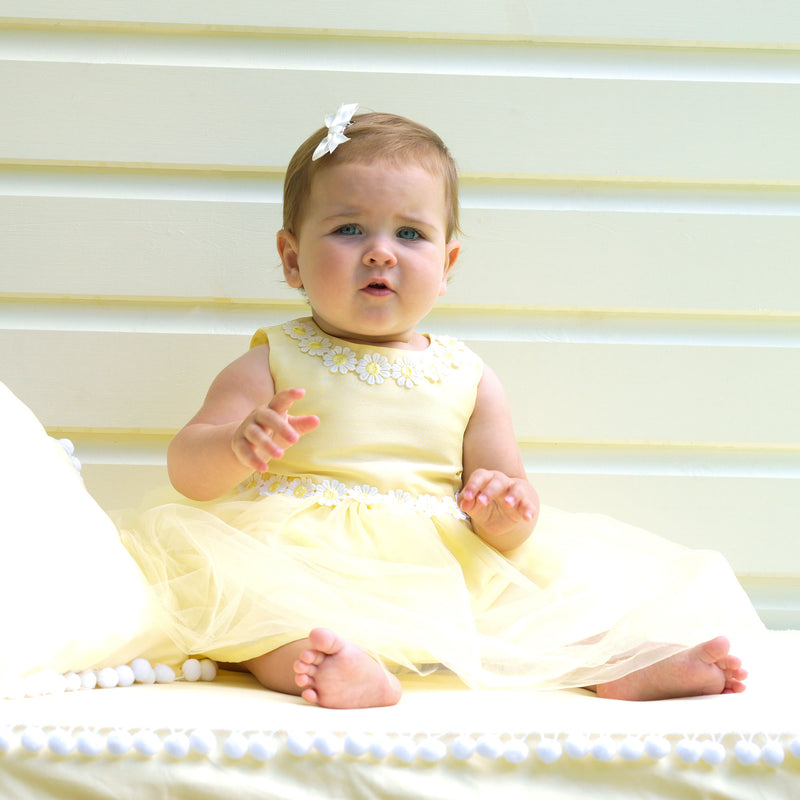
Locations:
0;183;800;313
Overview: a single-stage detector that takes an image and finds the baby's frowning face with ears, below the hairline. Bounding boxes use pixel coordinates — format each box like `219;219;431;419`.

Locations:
278;162;459;349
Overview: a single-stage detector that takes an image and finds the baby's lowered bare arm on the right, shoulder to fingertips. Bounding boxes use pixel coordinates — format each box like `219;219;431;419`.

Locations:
458;367;539;552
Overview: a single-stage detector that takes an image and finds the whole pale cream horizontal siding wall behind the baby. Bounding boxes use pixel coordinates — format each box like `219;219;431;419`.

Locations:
0;9;800;627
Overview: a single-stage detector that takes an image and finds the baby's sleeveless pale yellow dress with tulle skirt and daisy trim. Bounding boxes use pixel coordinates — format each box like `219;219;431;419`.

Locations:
117;318;761;688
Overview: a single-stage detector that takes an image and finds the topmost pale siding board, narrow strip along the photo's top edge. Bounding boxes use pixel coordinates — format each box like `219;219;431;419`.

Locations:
0;0;800;45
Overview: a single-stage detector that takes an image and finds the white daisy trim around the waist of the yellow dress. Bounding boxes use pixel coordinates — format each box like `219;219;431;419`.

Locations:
239;473;469;520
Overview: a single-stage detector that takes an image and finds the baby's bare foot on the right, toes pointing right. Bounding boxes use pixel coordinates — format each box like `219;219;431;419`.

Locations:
596;636;747;700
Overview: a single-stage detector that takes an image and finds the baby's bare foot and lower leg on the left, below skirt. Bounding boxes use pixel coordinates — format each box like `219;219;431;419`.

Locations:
243;628;401;708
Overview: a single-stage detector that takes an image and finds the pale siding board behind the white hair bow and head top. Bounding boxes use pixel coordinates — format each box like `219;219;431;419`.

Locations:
0;60;800;181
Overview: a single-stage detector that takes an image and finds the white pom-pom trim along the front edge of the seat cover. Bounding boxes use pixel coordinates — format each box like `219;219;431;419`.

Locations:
0;726;800;770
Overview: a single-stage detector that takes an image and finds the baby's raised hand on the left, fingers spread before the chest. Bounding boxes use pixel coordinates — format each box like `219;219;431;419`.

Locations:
231;389;319;472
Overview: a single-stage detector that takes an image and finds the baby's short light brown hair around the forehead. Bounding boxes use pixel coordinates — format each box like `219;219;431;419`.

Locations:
283;112;460;241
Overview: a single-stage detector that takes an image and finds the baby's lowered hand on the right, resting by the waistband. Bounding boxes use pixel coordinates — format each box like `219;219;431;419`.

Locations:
458;469;539;550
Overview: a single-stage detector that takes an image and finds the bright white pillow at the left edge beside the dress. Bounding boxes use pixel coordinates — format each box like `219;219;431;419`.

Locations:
0;383;169;683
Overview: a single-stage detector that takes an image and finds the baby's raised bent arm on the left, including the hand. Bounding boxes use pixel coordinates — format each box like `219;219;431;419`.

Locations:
167;345;319;500
